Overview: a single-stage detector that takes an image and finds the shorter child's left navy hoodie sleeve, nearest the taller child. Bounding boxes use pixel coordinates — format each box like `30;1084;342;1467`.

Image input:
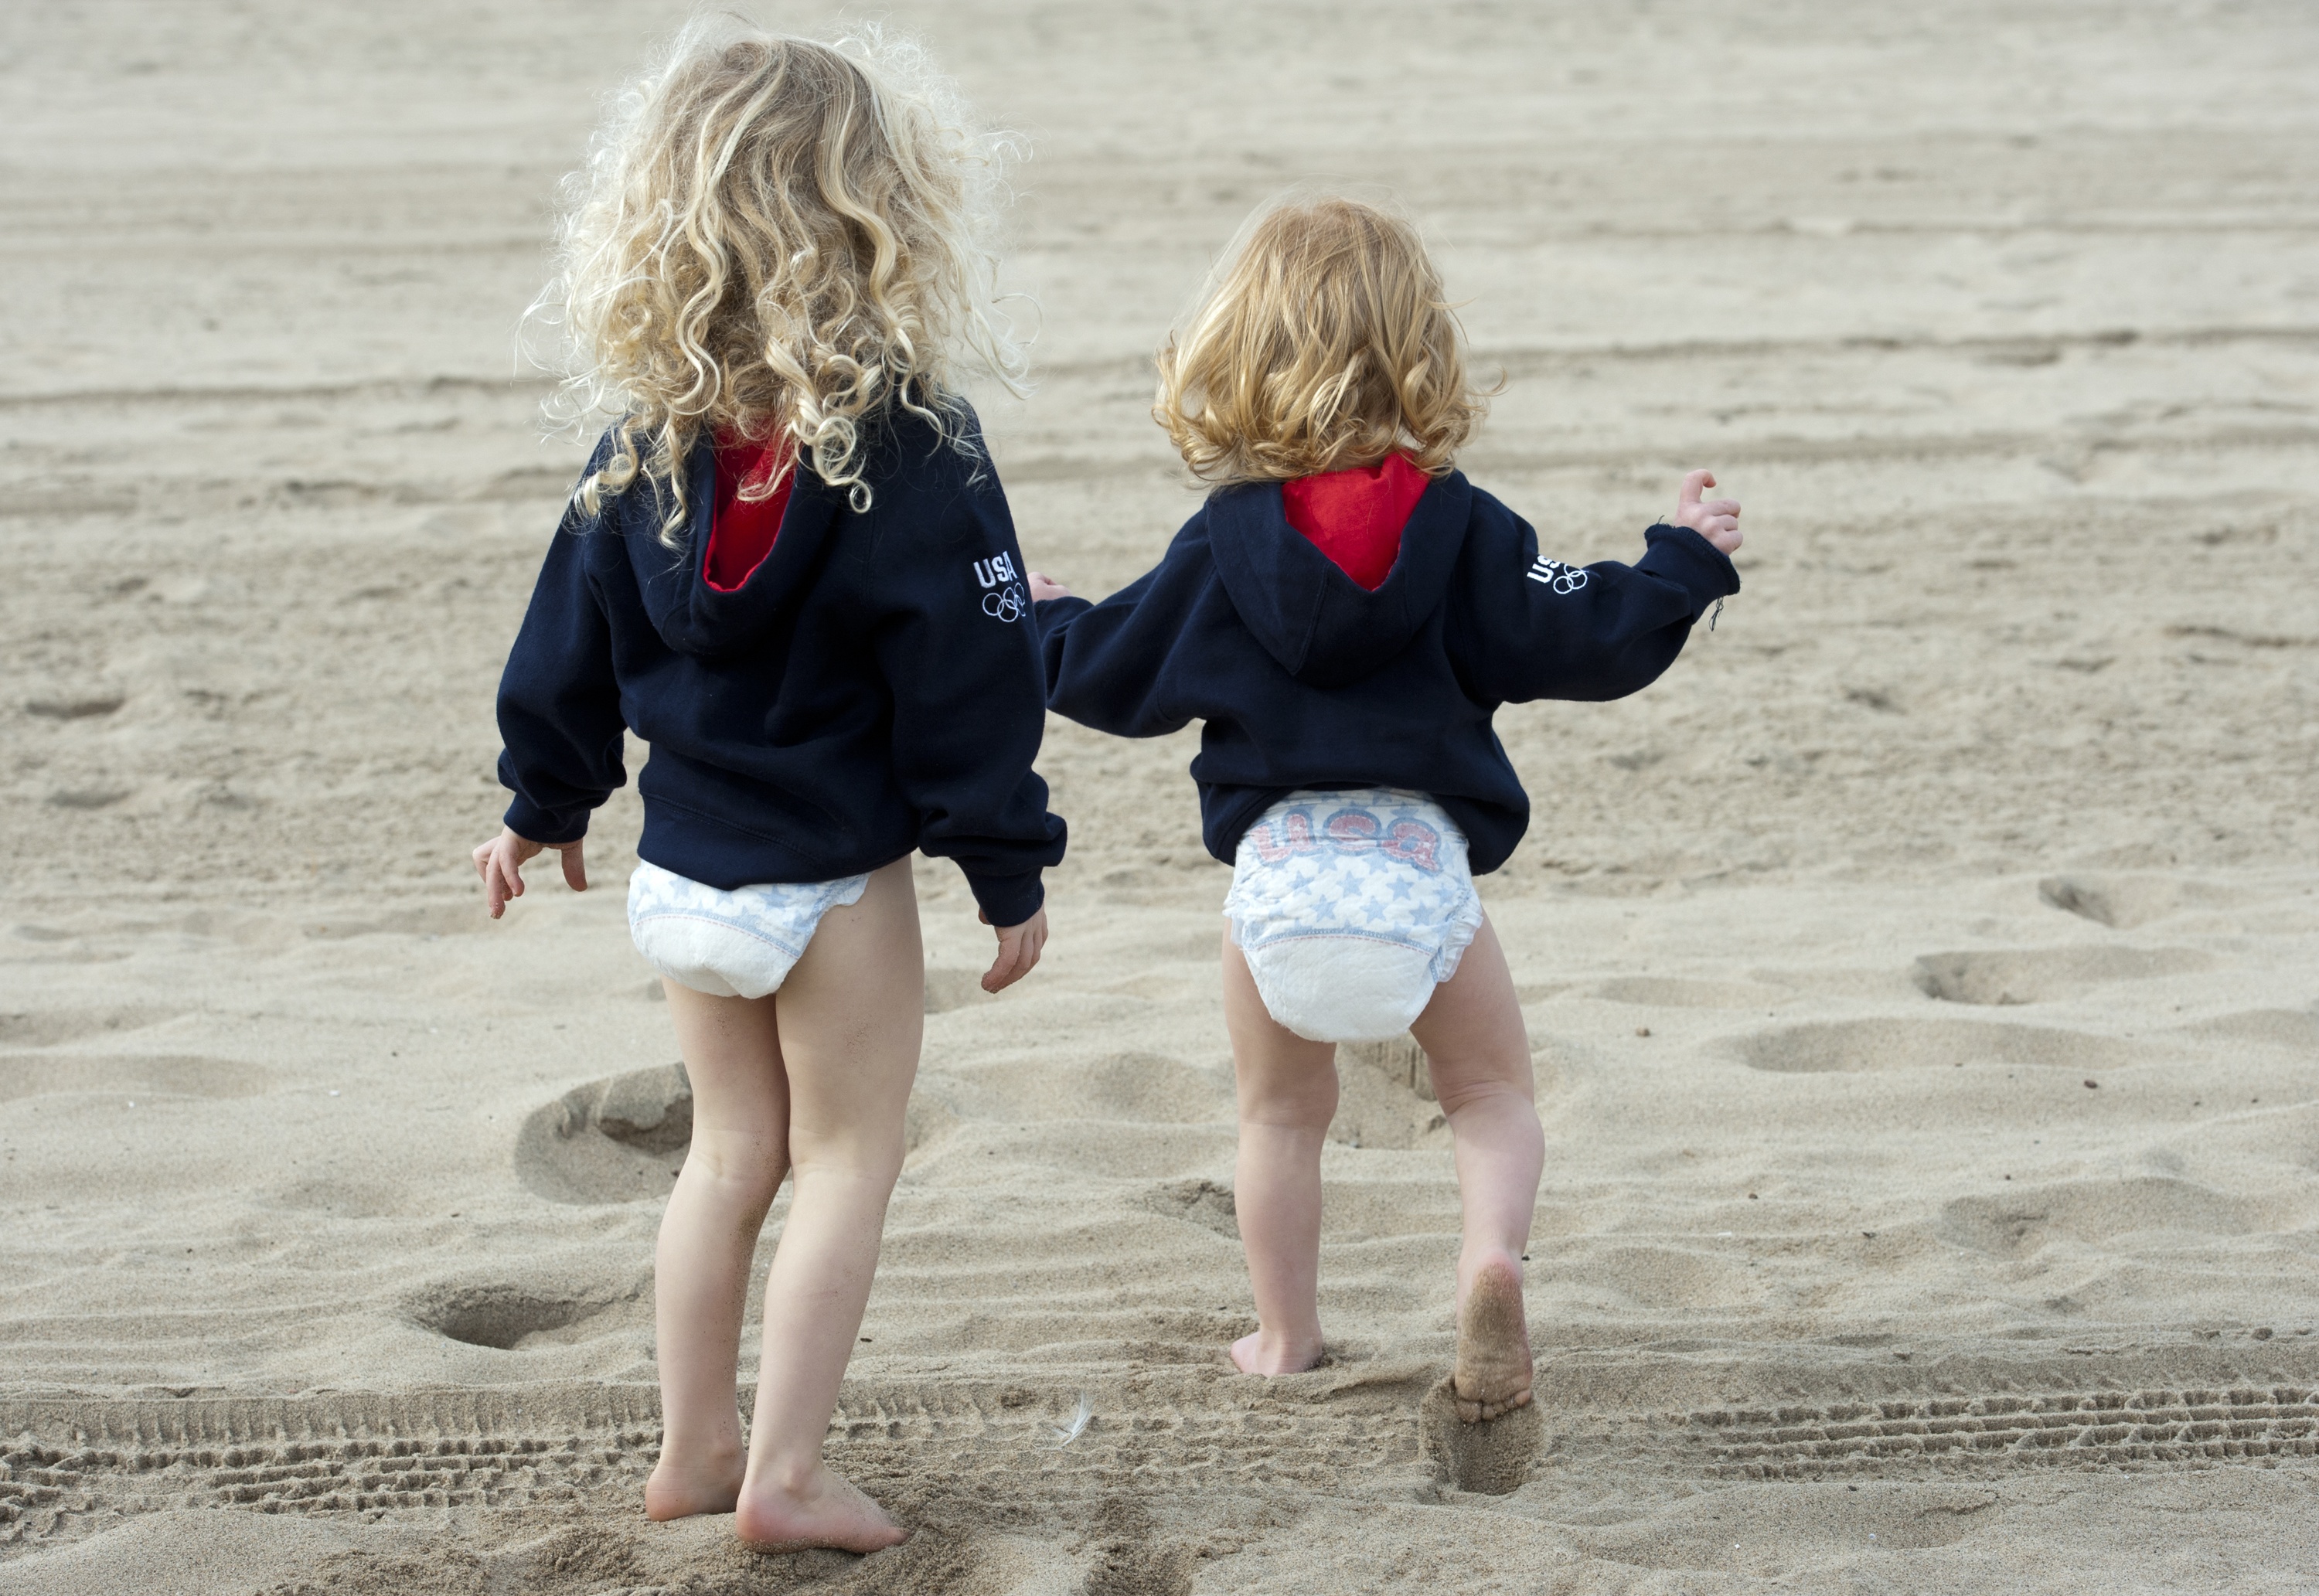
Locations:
1039;533;1215;737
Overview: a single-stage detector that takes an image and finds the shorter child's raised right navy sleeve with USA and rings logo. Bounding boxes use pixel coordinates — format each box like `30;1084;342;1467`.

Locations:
1452;512;1739;703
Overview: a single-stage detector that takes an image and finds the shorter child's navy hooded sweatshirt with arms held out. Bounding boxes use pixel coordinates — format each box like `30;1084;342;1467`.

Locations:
1039;471;1739;875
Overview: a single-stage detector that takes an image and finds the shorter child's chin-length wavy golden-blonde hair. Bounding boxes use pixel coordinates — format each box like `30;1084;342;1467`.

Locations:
1153;195;1489;485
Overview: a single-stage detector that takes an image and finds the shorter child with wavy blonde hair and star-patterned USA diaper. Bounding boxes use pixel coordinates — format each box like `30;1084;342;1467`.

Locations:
1030;197;1739;1422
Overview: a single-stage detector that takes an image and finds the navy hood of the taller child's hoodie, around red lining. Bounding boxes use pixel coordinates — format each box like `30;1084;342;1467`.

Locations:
608;438;844;658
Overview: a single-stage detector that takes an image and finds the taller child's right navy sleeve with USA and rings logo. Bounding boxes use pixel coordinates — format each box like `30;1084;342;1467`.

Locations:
877;468;1064;926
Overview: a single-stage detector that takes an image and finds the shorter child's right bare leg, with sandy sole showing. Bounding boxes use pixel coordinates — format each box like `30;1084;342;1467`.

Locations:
1410;921;1547;1422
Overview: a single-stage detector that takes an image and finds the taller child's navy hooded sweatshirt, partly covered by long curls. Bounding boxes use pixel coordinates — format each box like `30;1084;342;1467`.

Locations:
499;408;1064;926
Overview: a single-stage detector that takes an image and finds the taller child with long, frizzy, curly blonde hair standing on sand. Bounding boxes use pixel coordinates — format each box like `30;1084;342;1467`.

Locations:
475;19;1064;1552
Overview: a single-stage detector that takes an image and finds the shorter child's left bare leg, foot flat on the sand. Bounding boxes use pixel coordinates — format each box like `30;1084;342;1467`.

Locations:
1224;931;1336;1373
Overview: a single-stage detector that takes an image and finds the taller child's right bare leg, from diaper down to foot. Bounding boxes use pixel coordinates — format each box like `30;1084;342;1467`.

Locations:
735;859;925;1552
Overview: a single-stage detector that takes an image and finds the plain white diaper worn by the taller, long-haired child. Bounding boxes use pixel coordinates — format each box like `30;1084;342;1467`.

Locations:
628;863;870;998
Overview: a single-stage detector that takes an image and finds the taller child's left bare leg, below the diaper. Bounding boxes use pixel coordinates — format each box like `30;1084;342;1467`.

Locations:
645;982;788;1519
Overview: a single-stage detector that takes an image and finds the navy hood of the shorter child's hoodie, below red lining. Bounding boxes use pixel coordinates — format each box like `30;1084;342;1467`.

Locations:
1206;471;1473;686
